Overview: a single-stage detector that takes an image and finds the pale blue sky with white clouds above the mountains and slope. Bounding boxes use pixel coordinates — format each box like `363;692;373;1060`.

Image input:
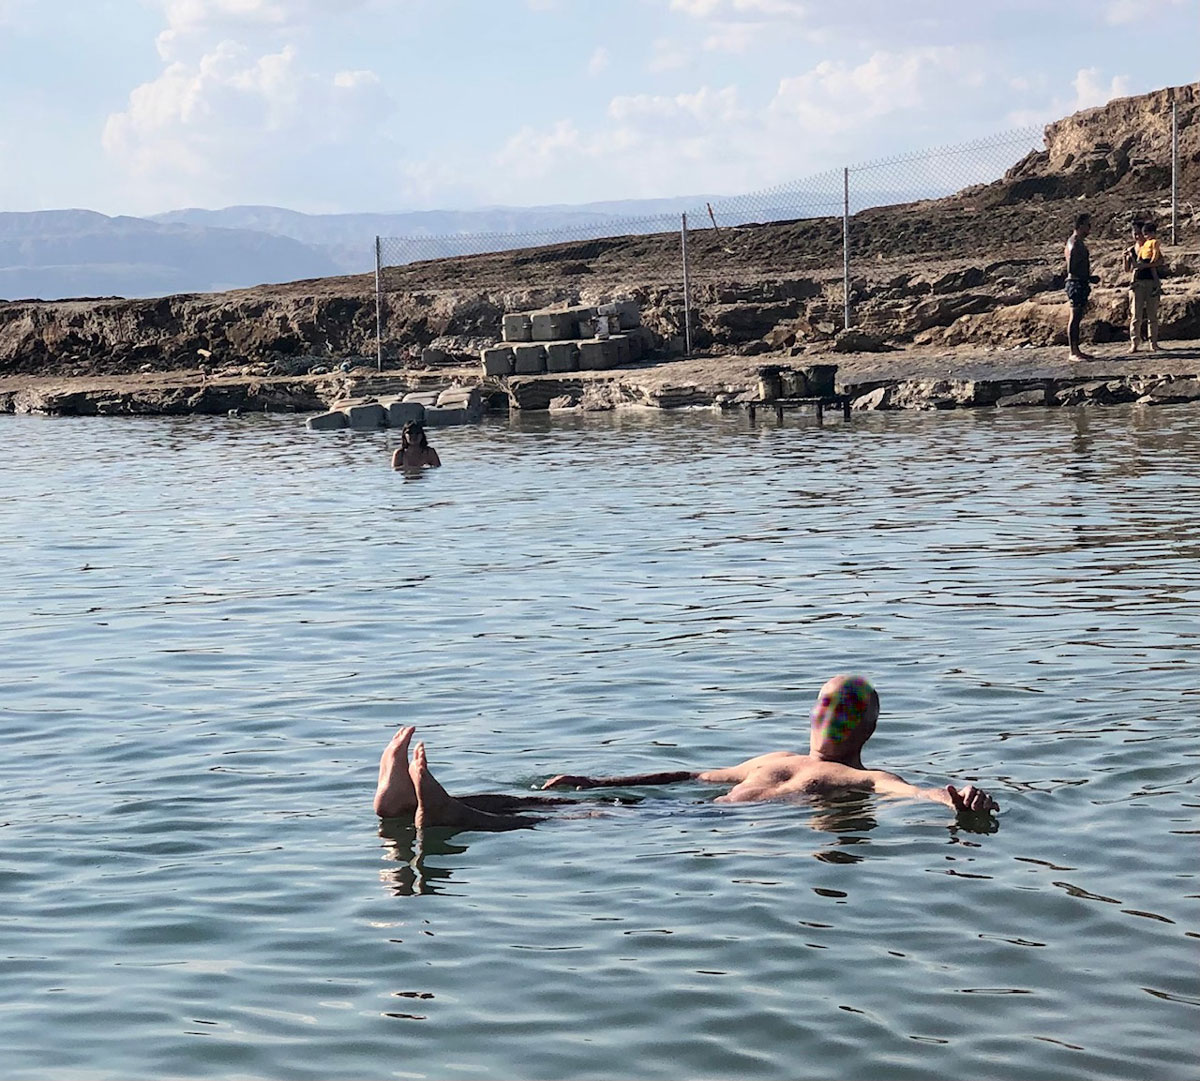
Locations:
0;0;1200;215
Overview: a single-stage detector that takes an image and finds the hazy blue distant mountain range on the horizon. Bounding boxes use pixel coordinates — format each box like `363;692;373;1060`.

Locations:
0;196;713;300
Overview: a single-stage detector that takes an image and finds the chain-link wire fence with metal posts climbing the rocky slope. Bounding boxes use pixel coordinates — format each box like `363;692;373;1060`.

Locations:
376;98;1200;374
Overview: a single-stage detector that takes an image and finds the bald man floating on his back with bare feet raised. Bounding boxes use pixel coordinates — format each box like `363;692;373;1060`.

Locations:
374;675;998;829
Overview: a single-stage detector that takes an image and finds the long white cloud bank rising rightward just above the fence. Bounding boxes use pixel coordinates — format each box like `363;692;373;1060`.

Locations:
468;38;1061;202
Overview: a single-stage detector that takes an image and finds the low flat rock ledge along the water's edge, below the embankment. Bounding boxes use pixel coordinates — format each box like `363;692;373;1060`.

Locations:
0;341;1200;416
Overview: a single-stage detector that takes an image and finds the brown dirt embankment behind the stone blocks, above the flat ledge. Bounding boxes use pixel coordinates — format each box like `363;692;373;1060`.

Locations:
0;80;1200;412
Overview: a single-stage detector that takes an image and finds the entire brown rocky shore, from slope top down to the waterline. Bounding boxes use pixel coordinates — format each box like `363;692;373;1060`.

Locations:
0;84;1200;416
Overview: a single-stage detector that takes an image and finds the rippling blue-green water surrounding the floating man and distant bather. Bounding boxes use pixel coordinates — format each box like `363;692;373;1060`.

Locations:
0;407;1200;1079
